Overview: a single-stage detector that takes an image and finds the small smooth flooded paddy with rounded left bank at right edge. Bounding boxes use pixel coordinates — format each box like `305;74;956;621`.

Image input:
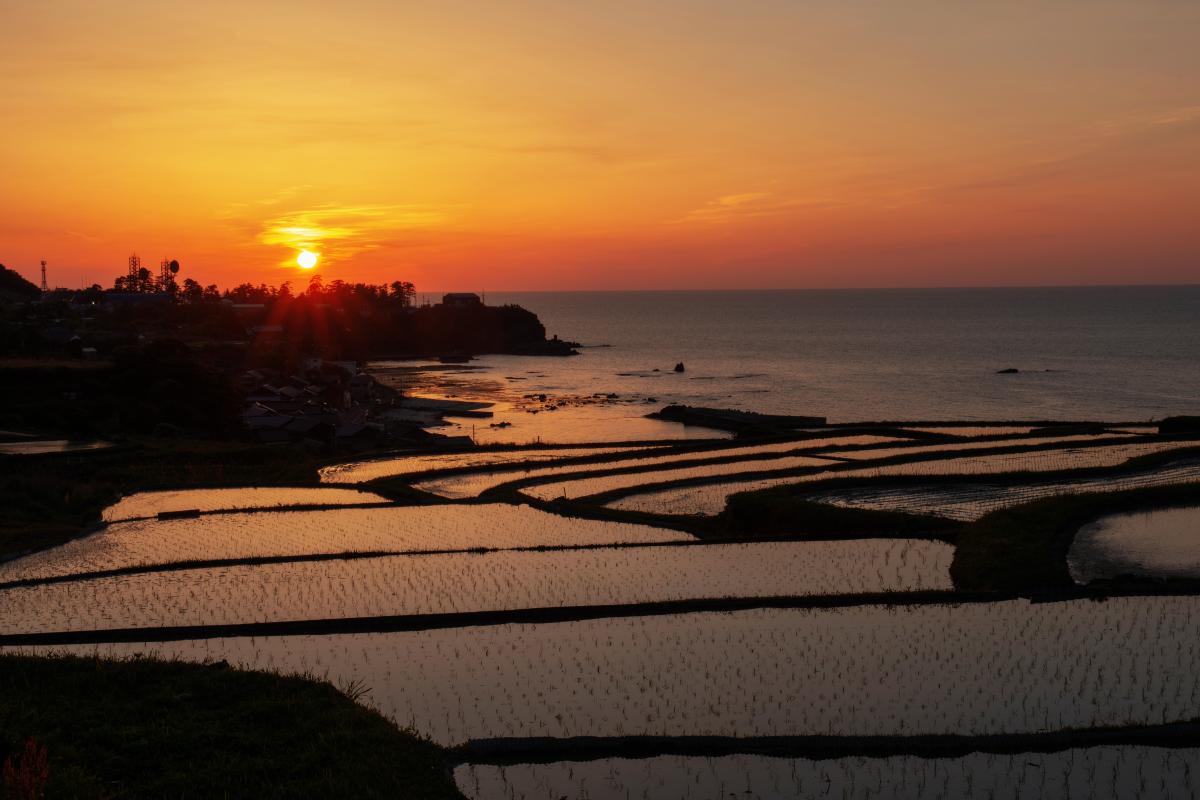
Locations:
1067;507;1200;583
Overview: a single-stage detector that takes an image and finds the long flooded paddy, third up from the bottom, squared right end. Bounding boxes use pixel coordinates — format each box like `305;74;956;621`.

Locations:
0;540;954;633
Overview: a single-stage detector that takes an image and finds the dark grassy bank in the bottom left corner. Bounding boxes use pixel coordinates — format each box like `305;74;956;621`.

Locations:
0;656;462;799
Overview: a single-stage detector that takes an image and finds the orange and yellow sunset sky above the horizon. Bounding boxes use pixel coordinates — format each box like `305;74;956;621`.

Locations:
0;0;1200;291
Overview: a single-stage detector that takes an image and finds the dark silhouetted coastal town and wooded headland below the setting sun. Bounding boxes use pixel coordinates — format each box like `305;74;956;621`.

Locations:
0;255;575;452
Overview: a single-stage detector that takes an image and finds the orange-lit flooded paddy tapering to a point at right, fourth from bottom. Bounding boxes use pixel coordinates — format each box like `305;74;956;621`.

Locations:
0;505;691;583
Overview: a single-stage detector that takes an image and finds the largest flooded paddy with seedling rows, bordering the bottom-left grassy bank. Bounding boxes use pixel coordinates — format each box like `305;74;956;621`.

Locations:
23;597;1200;744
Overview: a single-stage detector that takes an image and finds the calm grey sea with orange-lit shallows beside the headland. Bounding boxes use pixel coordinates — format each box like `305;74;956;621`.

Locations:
379;285;1200;441
